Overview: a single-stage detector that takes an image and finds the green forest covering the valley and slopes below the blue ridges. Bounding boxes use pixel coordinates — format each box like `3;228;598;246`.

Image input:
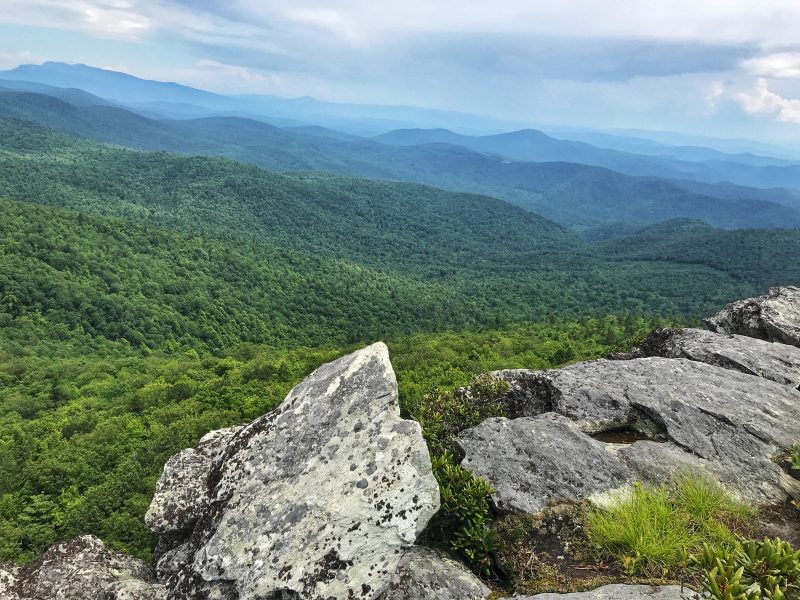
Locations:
0;119;800;563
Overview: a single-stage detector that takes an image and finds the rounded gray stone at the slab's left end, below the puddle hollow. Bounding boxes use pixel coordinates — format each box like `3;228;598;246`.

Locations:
458;413;631;513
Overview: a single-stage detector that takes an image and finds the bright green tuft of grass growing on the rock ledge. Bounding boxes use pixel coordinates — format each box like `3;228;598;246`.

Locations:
588;475;755;577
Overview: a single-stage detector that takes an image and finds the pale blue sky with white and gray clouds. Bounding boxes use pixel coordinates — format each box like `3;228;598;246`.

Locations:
0;0;800;141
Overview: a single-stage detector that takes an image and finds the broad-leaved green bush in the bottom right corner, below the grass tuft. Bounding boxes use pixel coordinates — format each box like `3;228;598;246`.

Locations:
690;538;800;600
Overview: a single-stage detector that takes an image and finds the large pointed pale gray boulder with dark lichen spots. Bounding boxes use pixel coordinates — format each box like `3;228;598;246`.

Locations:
161;344;439;600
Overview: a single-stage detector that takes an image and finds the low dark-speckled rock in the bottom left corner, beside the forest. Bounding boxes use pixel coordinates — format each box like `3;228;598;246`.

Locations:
11;535;163;600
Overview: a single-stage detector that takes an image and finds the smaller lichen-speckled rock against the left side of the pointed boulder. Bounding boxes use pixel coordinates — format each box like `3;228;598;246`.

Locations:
144;427;241;534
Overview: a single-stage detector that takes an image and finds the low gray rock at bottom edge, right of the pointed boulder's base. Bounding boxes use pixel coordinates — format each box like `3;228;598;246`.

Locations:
381;546;491;600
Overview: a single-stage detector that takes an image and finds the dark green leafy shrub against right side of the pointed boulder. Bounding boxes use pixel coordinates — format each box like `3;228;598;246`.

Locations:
429;454;497;577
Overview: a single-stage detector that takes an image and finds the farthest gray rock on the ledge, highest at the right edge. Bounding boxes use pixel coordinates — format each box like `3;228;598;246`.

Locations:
705;287;800;346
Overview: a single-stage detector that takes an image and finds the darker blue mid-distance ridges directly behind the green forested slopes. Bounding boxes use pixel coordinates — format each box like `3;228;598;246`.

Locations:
0;92;800;230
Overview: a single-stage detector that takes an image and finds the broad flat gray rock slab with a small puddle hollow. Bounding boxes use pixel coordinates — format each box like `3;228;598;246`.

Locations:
458;358;800;511
